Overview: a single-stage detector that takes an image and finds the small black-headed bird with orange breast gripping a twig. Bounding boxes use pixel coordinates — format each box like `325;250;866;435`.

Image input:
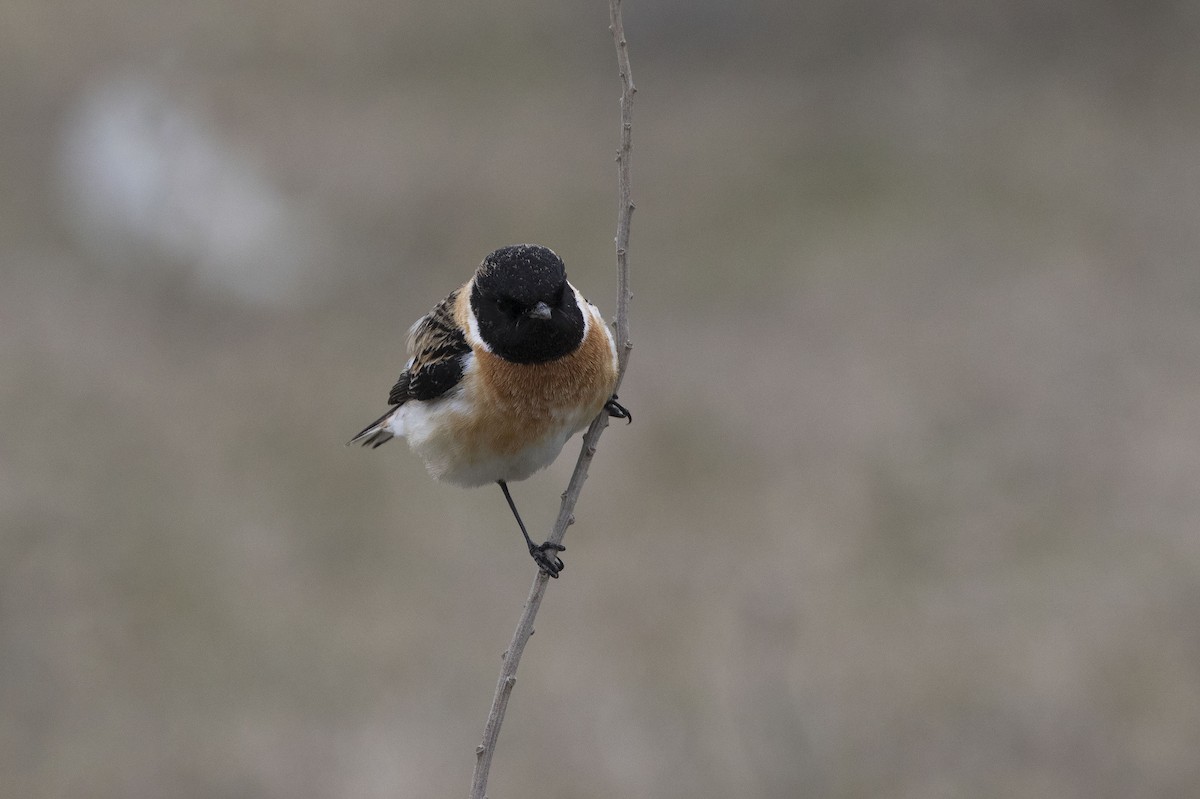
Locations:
347;244;632;578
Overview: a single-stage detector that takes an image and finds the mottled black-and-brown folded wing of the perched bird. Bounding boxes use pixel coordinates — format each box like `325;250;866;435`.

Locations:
388;292;470;405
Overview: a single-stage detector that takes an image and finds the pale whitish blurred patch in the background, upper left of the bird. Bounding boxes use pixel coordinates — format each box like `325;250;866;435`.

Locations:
58;76;330;305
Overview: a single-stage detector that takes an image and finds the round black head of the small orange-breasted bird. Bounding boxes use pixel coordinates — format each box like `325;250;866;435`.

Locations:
470;245;583;364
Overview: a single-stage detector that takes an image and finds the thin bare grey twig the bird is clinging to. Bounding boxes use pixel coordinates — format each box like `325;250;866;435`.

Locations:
470;0;637;799
